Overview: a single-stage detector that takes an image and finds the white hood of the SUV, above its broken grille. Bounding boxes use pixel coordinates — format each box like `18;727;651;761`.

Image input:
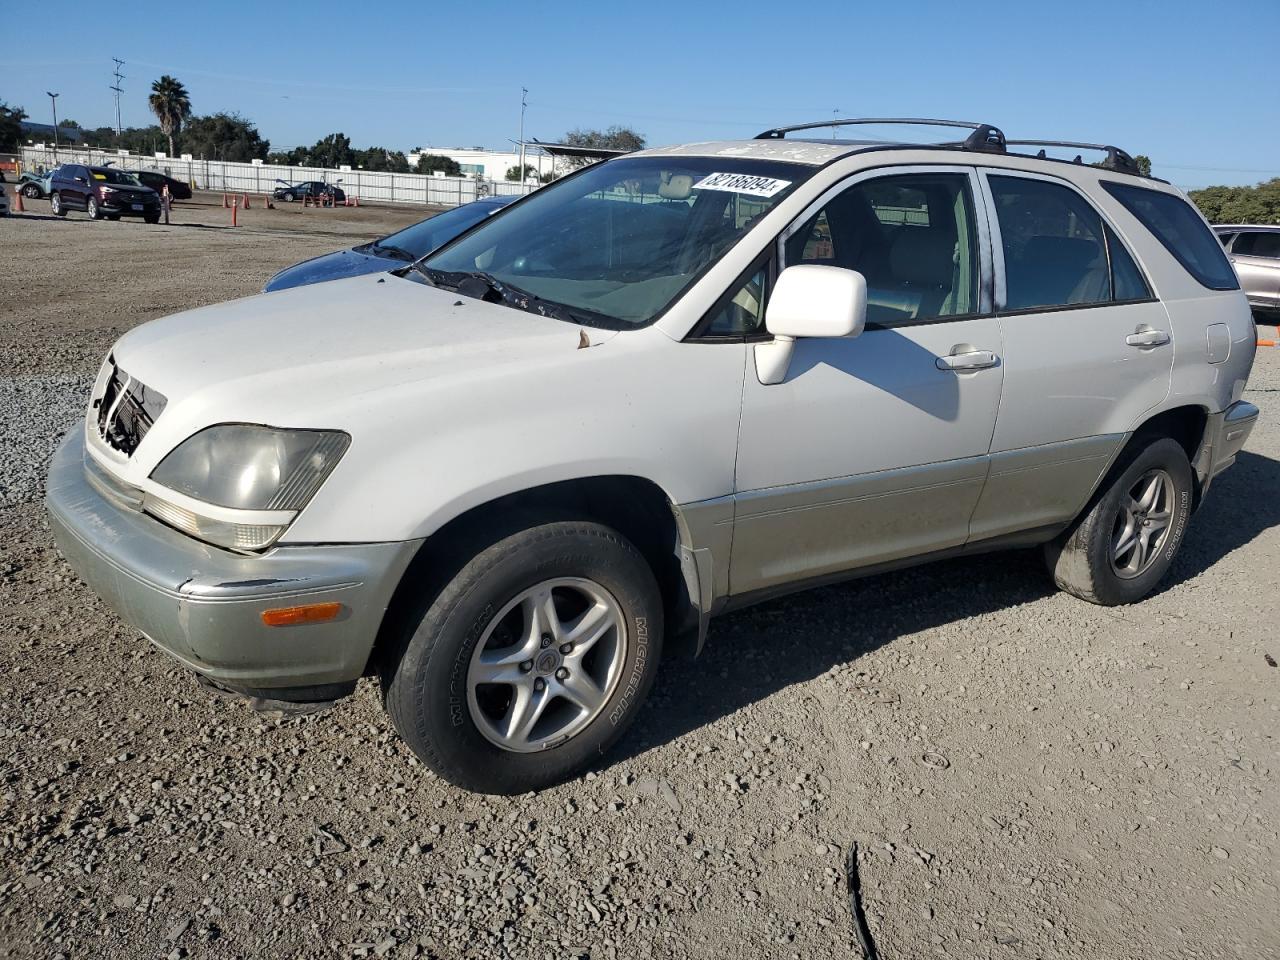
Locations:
113;274;616;466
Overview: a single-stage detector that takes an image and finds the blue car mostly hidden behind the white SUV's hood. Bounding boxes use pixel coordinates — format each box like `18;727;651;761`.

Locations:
262;197;517;293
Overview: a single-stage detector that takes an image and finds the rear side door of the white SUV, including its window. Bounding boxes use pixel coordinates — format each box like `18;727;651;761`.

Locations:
972;170;1174;540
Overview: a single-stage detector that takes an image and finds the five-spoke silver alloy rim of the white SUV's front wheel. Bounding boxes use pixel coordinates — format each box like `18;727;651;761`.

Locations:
467;577;627;753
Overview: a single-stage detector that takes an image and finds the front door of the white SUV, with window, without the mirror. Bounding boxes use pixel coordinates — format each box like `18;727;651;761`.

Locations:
730;166;1005;594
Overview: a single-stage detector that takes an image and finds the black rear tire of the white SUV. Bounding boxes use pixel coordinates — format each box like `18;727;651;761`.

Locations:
1044;436;1194;607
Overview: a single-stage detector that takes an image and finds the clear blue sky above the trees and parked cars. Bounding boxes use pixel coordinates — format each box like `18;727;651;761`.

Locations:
0;0;1280;187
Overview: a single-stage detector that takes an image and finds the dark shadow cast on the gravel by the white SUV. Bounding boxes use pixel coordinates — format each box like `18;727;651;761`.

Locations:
603;452;1280;767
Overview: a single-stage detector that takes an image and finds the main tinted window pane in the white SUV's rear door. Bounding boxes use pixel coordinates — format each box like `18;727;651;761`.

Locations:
987;177;1111;310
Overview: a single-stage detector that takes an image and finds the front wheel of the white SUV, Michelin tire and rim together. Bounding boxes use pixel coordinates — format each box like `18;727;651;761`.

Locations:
381;521;662;794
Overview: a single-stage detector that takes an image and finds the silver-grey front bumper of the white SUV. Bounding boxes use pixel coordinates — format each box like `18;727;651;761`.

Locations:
46;428;421;700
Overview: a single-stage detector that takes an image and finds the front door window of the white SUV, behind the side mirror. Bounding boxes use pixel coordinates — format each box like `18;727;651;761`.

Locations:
786;173;978;323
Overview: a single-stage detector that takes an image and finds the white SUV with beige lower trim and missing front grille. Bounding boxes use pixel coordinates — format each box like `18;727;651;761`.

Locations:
49;122;1258;792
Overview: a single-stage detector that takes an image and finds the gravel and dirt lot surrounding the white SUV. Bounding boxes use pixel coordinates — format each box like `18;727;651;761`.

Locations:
0;197;1280;960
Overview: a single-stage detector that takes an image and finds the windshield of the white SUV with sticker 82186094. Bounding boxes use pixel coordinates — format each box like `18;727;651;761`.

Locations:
424;156;813;329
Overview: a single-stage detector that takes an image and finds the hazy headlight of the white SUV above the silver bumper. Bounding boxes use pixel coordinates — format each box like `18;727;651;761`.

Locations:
143;424;351;550
